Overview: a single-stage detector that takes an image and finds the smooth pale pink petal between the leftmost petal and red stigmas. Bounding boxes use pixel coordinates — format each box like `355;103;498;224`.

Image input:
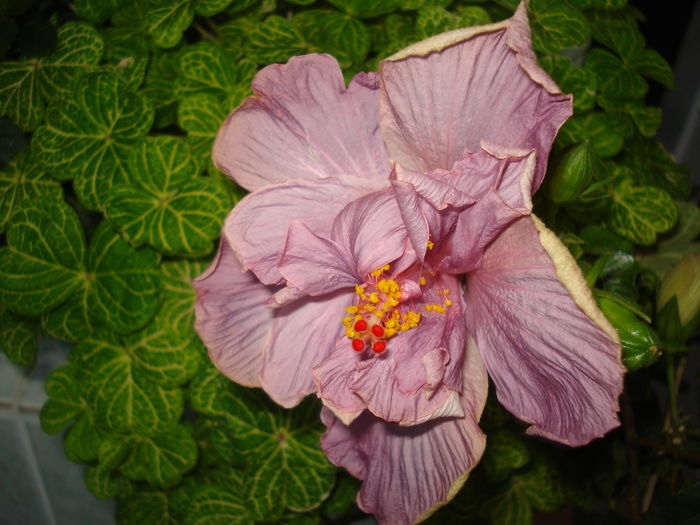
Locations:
261;292;353;408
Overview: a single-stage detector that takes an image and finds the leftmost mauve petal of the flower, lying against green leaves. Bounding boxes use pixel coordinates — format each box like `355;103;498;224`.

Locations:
192;238;273;386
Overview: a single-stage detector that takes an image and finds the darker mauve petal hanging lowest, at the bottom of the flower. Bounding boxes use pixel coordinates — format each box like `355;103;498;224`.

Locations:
321;340;488;525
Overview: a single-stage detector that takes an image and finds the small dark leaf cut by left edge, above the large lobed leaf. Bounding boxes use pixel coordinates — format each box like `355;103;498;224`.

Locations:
0;146;63;233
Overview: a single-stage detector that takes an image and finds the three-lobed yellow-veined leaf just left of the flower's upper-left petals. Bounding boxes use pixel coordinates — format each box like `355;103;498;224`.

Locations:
106;137;231;256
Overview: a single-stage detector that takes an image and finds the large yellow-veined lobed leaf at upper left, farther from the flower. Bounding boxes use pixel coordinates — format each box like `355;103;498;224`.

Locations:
35;75;153;210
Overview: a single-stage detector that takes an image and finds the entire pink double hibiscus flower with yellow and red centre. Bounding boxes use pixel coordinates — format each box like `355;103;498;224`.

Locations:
194;5;623;524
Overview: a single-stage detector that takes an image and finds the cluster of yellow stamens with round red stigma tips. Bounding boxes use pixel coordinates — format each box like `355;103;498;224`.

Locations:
343;264;421;354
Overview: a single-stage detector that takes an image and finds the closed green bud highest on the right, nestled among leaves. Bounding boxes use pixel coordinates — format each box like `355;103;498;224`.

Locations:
547;140;595;204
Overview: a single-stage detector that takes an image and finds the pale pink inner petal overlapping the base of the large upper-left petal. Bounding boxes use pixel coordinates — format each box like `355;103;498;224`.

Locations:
224;177;363;284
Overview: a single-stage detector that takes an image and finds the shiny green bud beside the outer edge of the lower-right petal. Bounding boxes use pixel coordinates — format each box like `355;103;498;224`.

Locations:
598;297;659;371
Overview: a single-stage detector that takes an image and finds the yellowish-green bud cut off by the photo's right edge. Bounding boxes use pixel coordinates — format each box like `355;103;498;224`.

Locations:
656;253;700;346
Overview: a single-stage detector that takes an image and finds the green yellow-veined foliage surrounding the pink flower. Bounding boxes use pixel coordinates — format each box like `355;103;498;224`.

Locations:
0;0;700;525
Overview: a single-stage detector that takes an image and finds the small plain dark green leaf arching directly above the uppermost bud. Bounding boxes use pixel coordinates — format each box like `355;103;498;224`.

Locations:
557;111;625;158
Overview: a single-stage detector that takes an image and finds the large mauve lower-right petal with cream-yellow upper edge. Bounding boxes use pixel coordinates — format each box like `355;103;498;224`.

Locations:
466;217;624;446
